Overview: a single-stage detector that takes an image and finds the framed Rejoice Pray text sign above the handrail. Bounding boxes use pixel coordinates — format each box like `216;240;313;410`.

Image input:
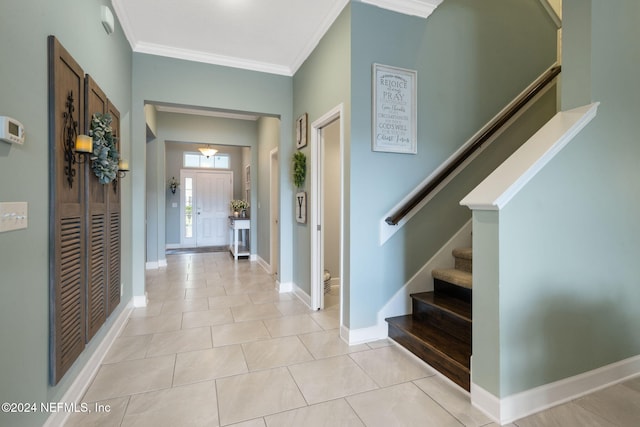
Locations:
371;64;418;154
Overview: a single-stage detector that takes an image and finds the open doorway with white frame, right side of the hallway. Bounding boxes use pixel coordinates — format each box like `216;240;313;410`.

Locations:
309;105;344;325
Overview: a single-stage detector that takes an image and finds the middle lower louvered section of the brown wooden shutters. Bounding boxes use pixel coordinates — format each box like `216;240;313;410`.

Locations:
87;214;107;342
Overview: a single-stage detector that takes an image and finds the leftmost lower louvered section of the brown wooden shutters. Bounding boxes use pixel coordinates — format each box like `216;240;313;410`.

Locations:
54;217;84;380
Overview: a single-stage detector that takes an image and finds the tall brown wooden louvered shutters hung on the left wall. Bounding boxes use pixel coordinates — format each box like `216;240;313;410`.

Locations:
47;36;120;385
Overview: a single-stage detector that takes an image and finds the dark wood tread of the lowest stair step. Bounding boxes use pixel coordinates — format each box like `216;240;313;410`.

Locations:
386;315;471;372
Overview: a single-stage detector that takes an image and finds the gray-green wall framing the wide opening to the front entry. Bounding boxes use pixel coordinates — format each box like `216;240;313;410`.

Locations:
131;54;293;296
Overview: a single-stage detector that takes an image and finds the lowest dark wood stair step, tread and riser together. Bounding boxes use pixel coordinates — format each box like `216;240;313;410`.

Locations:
386;315;471;390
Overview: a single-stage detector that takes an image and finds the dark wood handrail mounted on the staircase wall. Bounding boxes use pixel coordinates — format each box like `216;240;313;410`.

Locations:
385;65;561;225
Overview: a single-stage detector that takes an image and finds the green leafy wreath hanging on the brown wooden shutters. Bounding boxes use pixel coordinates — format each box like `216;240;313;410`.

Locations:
89;113;120;184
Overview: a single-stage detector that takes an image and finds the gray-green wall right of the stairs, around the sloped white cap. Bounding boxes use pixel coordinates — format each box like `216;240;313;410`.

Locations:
473;0;640;398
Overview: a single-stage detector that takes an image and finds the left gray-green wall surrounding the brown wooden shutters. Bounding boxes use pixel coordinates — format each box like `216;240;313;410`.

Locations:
0;0;131;427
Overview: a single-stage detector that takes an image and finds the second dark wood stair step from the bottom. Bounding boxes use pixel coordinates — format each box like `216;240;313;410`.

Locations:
411;292;471;346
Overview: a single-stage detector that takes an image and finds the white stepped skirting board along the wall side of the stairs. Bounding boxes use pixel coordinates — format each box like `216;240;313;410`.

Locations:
378;220;472;324
